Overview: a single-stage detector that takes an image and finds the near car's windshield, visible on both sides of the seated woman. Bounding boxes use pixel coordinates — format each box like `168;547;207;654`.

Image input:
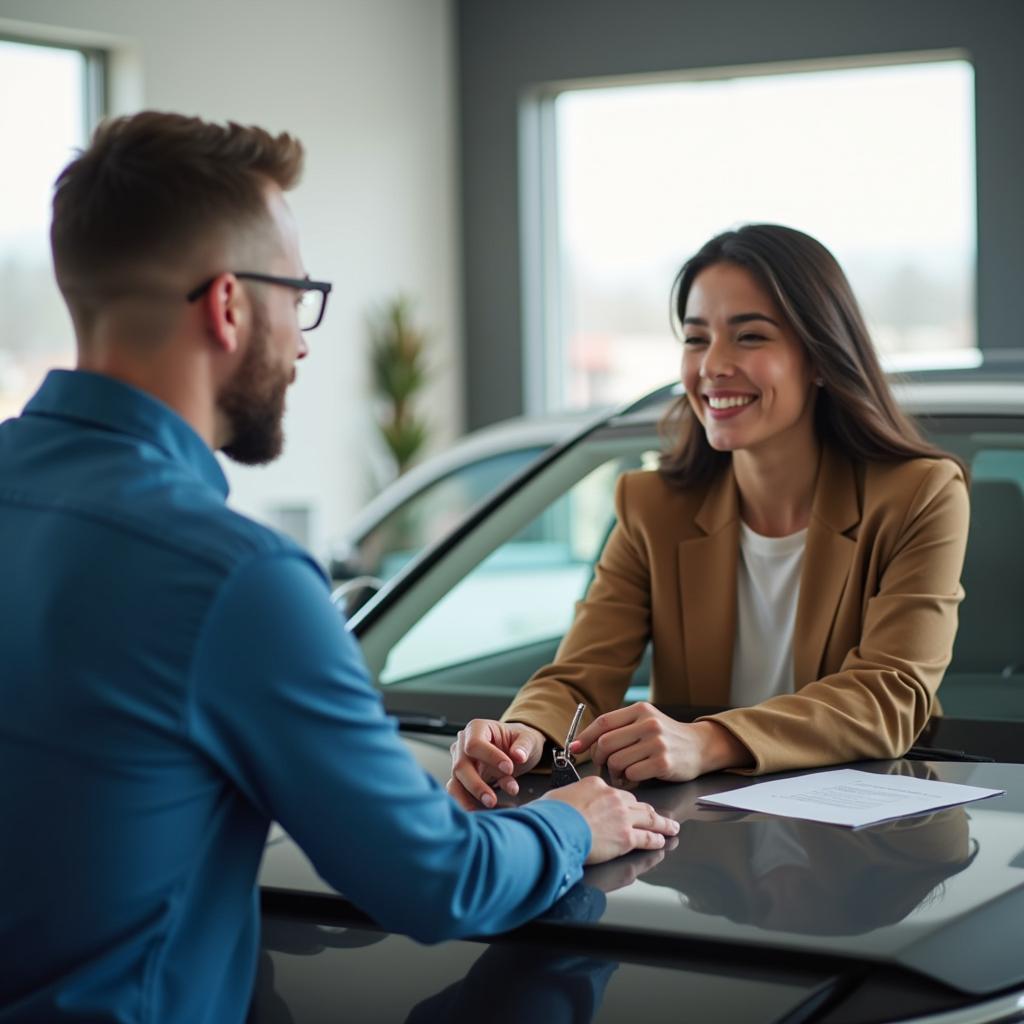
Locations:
356;399;1024;721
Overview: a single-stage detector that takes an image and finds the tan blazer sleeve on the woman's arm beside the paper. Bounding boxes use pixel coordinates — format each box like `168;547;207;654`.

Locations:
709;460;969;774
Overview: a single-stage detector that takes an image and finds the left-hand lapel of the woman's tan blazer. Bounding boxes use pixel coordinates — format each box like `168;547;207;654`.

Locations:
678;471;739;706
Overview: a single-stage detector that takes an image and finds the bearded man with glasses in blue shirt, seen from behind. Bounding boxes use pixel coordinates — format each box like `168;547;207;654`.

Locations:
0;113;678;1024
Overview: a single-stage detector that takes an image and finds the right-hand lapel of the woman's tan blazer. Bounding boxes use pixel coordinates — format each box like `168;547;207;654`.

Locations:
793;447;860;690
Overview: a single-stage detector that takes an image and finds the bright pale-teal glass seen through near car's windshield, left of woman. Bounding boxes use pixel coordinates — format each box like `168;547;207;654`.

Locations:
380;454;640;687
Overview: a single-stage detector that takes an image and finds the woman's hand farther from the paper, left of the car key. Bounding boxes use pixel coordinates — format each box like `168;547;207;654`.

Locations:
447;718;546;811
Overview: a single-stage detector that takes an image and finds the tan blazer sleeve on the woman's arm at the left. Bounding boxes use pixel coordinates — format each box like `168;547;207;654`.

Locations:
502;474;650;743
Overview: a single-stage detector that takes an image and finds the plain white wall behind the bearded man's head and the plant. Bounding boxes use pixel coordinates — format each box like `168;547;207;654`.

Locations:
0;0;461;554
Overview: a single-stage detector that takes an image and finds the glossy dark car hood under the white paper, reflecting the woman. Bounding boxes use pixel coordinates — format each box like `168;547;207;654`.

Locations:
261;737;1024;1020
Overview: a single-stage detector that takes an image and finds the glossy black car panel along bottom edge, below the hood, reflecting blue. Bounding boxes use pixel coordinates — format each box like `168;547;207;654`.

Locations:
250;921;827;1024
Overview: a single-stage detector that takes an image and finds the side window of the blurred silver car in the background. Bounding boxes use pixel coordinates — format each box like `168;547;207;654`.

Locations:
358;445;545;580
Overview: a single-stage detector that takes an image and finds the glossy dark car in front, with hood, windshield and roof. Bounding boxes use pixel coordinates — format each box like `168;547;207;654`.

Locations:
254;380;1024;1024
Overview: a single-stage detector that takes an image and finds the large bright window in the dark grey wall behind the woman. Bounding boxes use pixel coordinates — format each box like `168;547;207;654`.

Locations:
523;59;976;410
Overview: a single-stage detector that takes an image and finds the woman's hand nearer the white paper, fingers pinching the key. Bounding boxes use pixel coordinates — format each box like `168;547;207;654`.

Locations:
569;701;754;782
